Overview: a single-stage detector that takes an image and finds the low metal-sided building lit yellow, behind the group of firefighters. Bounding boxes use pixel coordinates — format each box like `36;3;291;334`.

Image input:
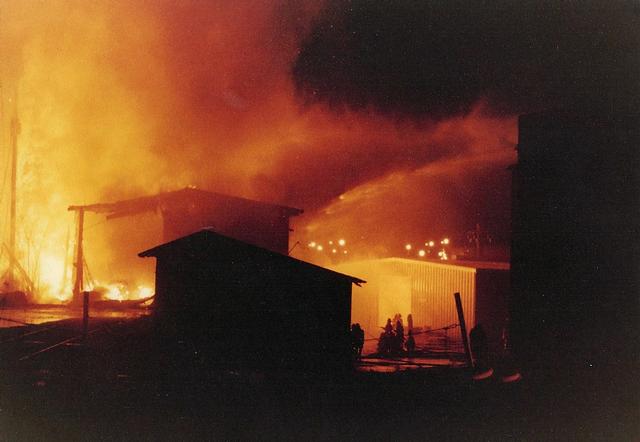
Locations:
337;258;510;343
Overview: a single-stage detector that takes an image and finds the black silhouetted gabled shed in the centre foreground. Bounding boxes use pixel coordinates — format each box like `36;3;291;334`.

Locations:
140;230;364;369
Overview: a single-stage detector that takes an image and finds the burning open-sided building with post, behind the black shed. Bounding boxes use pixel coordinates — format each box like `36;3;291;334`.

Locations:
64;188;302;297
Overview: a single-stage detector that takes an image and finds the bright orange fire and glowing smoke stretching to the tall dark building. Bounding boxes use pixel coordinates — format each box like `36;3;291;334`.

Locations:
0;0;515;302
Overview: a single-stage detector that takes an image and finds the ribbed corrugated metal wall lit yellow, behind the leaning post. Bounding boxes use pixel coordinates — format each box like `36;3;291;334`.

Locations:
379;258;476;329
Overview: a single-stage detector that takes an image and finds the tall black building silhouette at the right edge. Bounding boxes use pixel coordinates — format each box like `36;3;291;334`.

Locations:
511;113;640;368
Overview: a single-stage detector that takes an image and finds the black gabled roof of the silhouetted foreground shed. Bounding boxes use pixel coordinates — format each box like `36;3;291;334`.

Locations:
138;229;366;285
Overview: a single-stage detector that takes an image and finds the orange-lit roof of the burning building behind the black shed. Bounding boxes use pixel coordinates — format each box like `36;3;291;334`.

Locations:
69;187;303;218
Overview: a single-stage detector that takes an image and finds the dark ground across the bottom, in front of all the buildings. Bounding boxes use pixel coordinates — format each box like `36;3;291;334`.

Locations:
0;319;640;441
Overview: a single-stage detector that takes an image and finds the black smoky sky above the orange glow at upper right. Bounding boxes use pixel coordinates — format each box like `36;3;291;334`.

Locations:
293;0;640;119
